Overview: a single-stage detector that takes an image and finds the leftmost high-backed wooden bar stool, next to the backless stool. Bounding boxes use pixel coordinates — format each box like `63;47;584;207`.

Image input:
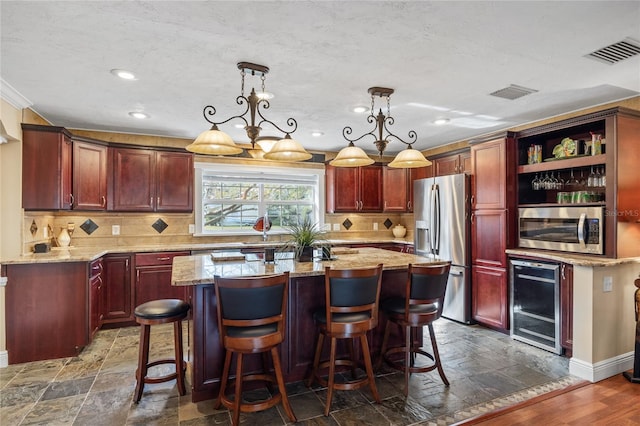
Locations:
214;272;297;426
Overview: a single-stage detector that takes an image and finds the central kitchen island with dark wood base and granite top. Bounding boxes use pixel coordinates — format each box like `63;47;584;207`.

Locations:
171;248;444;402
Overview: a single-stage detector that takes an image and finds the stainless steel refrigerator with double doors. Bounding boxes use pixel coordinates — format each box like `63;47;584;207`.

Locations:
413;173;471;324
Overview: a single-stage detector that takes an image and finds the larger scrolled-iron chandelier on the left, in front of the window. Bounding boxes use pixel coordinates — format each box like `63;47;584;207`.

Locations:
186;62;311;161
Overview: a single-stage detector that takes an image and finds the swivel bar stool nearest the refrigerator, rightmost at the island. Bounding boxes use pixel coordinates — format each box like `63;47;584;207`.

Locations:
378;263;451;396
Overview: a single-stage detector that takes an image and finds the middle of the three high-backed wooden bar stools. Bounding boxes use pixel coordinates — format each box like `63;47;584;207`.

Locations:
307;264;382;416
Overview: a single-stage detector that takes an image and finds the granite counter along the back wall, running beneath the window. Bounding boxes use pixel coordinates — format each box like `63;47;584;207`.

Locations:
0;238;413;265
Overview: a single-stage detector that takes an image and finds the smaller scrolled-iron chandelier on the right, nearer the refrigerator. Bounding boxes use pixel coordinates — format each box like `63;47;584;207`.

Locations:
329;87;431;168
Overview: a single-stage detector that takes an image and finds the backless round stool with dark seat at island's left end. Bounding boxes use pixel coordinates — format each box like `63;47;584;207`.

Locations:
134;299;190;403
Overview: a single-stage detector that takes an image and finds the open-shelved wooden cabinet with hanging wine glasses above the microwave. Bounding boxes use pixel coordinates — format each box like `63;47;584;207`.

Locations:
517;108;640;258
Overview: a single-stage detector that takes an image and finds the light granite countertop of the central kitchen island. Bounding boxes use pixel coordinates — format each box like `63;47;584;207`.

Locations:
171;247;448;286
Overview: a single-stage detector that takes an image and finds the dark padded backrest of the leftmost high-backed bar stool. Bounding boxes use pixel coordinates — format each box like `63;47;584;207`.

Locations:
215;272;289;344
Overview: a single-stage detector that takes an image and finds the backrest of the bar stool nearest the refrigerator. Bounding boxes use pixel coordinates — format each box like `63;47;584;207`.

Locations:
405;262;451;321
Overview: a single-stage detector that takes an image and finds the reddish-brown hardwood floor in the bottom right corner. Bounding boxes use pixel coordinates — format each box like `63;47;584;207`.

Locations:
461;374;640;426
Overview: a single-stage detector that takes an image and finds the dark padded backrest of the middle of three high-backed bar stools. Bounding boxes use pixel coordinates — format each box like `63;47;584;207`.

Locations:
325;264;382;332
